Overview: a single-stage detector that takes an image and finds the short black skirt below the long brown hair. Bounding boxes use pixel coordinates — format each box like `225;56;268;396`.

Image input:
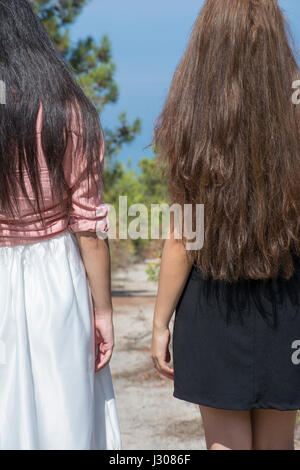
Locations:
173;255;300;410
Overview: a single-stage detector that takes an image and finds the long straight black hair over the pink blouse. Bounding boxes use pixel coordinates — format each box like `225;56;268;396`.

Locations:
0;0;103;224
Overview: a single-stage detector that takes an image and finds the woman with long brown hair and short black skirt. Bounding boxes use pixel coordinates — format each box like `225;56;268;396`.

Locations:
152;0;300;450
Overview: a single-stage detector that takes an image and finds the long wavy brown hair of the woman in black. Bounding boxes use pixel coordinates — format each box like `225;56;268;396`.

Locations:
154;0;300;281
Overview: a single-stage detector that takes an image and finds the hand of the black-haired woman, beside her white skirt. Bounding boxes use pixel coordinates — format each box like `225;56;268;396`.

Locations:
94;315;114;372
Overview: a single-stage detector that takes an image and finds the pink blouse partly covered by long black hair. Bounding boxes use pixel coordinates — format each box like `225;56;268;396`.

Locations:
0;108;108;246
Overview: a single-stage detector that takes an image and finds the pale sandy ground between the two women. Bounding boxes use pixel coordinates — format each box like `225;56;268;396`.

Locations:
111;265;300;450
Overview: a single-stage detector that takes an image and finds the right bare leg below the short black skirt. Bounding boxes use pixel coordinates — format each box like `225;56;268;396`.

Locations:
251;409;297;450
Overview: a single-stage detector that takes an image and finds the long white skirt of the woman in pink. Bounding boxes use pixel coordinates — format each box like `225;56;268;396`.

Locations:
0;231;121;450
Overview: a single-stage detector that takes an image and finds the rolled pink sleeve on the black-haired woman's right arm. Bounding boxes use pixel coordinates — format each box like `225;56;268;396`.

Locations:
65;132;109;232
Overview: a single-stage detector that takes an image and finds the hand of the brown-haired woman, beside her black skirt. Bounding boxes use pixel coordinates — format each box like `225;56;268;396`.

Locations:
151;327;174;380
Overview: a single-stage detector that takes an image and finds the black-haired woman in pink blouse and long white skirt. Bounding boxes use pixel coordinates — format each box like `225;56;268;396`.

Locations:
0;0;121;450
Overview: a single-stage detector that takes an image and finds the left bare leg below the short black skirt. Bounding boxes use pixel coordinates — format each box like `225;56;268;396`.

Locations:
200;406;252;450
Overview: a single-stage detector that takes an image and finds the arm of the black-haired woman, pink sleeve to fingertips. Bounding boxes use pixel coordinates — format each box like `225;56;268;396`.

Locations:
64;120;114;371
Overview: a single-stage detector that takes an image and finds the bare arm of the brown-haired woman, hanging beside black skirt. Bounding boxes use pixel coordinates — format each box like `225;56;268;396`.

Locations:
151;229;192;379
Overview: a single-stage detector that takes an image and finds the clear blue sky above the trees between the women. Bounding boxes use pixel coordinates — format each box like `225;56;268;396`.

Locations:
71;0;300;167
